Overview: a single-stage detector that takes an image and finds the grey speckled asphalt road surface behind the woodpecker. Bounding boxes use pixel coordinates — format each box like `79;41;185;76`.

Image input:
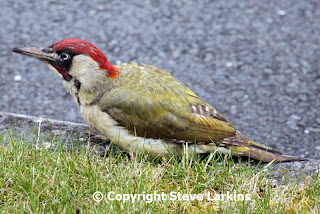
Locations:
0;0;320;159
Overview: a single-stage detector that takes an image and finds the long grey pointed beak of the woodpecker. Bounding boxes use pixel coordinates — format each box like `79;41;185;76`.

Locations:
12;47;59;63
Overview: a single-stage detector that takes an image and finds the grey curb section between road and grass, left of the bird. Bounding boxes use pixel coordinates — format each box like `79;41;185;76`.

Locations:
0;112;114;156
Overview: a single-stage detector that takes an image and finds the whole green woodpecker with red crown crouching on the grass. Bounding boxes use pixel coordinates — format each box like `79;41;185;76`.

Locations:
12;39;303;162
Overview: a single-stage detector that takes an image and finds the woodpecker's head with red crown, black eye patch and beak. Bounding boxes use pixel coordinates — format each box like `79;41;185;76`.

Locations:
12;39;119;82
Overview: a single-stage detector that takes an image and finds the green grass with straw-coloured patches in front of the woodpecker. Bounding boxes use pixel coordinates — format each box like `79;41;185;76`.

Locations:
0;130;320;213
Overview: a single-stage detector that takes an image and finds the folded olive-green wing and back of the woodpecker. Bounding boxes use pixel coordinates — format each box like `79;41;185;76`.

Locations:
99;64;235;142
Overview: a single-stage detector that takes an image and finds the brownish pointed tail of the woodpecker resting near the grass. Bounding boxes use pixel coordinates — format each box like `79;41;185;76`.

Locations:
222;131;308;162
